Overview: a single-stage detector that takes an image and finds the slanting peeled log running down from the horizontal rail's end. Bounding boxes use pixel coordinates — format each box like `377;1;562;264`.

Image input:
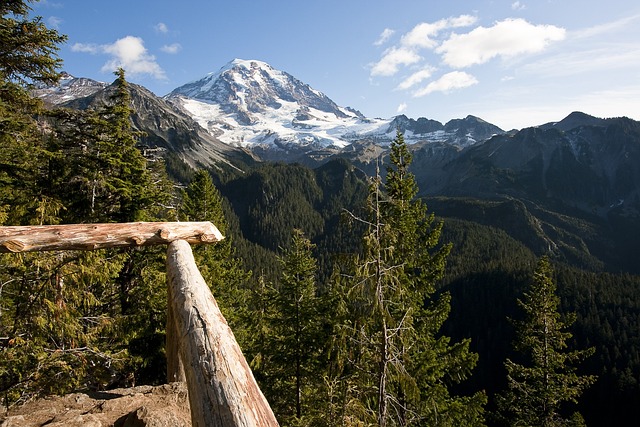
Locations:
167;241;278;427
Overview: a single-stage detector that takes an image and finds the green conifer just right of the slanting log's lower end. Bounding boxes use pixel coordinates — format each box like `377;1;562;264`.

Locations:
232;229;334;426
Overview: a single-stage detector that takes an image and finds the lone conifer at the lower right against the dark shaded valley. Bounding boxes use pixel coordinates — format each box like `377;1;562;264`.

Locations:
498;256;595;427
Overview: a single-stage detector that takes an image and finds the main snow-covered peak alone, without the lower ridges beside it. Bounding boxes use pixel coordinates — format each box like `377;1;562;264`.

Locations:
167;59;380;147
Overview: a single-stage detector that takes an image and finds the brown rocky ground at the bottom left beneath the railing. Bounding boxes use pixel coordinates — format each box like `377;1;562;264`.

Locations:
0;383;191;427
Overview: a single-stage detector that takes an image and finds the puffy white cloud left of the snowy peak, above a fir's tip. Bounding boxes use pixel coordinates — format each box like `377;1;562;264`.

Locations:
102;36;166;80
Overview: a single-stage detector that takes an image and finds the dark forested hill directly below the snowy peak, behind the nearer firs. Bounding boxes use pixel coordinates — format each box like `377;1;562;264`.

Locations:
220;160;366;285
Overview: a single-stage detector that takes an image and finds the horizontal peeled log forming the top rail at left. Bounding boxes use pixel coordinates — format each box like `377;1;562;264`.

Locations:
0;222;224;252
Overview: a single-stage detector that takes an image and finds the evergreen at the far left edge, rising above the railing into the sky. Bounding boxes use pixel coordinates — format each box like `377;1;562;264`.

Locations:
0;0;66;224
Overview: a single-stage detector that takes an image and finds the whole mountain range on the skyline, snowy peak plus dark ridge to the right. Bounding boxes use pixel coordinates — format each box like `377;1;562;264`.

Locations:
37;60;640;221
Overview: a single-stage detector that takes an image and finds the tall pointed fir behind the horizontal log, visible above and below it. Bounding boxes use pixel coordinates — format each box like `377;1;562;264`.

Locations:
98;68;174;383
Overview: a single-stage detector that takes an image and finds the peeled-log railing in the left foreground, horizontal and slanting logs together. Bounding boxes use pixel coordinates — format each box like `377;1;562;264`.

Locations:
0;222;278;427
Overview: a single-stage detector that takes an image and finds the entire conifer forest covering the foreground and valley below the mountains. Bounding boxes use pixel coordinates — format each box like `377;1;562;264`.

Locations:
0;0;640;427
